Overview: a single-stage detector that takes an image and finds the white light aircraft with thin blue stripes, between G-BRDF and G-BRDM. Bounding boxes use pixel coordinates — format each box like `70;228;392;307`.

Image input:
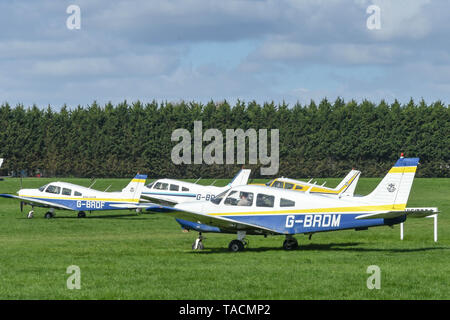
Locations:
141;169;251;204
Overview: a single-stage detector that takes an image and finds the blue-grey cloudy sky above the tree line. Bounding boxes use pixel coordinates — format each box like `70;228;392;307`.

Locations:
0;0;450;109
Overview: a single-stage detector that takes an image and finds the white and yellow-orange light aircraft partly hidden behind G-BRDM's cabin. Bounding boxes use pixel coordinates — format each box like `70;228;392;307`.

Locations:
266;170;361;197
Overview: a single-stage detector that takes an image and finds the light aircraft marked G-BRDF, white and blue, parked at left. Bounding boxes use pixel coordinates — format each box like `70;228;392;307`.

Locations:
0;174;153;218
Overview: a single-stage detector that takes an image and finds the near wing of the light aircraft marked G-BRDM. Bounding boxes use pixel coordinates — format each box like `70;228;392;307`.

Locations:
147;206;281;234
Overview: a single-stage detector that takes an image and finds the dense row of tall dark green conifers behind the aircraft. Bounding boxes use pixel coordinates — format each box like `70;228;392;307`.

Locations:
0;98;450;179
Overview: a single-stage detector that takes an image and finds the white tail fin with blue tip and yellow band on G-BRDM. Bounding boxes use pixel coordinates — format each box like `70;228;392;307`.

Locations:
365;157;419;210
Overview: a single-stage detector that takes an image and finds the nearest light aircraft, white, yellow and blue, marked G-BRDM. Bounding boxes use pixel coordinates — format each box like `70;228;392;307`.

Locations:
148;157;435;252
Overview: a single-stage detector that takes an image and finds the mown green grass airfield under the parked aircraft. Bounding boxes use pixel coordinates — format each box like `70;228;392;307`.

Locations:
0;178;450;300
